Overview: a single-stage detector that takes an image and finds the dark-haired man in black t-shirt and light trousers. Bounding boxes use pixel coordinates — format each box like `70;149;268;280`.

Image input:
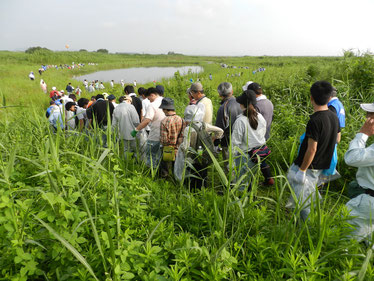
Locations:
287;81;340;220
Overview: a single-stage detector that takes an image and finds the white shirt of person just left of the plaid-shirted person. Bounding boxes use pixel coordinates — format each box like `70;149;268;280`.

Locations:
144;97;166;141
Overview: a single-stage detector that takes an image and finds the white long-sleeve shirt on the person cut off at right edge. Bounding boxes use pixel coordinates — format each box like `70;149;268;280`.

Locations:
344;133;374;190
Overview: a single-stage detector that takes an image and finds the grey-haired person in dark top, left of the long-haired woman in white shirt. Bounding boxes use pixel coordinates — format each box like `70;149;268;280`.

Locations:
215;82;243;173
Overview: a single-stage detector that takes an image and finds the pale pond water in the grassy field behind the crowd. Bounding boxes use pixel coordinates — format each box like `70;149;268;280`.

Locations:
74;66;204;84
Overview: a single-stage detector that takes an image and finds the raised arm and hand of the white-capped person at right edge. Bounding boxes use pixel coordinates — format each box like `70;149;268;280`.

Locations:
344;117;374;167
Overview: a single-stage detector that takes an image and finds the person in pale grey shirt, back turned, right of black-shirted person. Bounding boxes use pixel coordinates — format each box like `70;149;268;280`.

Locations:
112;96;140;157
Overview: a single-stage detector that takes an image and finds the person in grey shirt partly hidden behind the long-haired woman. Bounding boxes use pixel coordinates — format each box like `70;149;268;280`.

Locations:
247;83;274;140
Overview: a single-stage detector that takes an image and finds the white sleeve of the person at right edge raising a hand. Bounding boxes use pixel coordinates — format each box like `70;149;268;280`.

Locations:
344;133;374;167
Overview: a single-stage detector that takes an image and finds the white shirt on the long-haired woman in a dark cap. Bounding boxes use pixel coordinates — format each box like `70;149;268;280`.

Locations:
231;113;266;154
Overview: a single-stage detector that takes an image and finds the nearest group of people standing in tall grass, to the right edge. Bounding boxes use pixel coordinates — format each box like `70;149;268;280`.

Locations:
46;78;374;243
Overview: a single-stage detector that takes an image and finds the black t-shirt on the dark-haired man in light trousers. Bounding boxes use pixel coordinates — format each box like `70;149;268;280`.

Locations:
295;110;340;170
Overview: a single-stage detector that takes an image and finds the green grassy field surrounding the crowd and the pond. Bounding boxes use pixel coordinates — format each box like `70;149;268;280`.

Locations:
0;52;374;281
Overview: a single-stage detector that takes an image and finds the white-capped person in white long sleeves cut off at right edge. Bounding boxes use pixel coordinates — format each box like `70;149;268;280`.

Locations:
344;103;374;244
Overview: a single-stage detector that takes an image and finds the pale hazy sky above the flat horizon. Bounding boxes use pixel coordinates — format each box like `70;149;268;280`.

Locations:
0;0;374;56
